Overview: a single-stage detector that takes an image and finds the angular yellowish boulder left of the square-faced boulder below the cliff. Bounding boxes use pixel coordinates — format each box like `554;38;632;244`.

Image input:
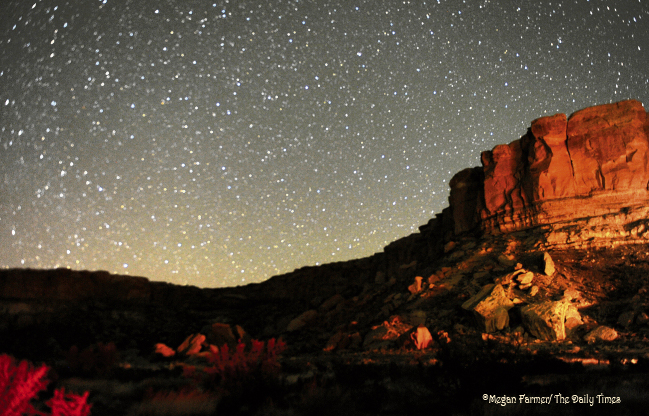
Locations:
462;284;514;333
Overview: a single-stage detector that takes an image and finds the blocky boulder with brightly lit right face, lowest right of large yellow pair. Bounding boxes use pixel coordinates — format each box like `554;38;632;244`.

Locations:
521;300;571;341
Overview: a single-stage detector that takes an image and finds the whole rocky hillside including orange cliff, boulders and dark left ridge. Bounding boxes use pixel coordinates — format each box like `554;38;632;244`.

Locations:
0;101;649;414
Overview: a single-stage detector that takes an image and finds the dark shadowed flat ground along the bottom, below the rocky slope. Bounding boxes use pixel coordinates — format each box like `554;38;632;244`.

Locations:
19;347;649;415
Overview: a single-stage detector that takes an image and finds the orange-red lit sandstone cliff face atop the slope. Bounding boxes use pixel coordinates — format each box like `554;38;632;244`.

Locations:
444;100;649;237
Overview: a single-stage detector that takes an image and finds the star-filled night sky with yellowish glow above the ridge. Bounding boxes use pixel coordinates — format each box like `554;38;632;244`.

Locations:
0;0;649;287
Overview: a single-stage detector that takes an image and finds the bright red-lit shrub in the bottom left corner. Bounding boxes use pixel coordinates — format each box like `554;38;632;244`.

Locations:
0;354;90;416
